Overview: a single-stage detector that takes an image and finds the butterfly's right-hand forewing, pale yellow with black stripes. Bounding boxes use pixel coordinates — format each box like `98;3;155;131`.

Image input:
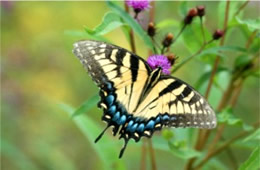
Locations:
134;75;217;129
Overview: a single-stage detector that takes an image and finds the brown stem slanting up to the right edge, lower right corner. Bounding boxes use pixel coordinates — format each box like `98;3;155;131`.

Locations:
194;122;260;169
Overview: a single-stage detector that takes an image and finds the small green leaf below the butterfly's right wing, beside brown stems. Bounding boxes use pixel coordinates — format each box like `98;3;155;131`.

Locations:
168;141;201;159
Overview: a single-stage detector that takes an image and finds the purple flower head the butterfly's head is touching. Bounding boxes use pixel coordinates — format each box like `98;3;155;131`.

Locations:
147;55;171;74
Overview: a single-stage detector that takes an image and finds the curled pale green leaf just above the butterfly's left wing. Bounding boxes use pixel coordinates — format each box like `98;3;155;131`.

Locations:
85;12;124;35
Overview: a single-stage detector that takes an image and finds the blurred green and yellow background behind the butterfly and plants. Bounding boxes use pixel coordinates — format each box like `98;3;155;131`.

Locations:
1;1;259;170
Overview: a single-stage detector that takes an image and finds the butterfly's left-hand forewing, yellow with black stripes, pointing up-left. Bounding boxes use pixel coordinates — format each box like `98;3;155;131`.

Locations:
74;41;150;113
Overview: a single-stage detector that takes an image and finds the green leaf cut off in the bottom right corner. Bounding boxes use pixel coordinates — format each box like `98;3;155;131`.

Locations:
239;146;260;170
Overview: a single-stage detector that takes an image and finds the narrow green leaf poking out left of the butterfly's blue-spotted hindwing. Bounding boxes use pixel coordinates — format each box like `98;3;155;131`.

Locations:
72;95;99;118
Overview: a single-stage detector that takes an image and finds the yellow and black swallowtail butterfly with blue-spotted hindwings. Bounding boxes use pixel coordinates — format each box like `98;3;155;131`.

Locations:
73;40;217;158
